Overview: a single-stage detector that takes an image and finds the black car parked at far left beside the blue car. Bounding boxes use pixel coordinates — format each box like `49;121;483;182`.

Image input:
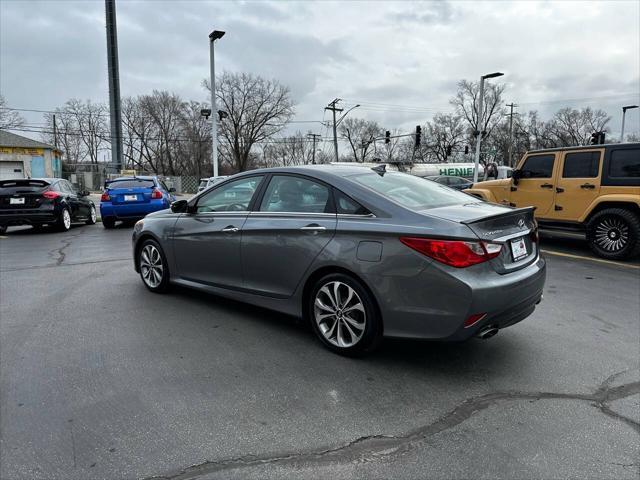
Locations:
0;178;96;233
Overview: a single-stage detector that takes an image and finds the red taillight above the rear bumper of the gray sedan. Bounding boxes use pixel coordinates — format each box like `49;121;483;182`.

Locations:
400;237;502;268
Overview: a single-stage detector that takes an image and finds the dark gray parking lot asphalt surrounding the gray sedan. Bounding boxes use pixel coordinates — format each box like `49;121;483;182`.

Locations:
0;224;640;479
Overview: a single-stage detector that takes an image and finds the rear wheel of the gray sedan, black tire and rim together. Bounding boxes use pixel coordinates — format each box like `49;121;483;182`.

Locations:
306;273;383;356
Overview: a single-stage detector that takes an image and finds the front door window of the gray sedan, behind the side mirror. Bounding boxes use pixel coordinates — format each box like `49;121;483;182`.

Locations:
196;175;263;213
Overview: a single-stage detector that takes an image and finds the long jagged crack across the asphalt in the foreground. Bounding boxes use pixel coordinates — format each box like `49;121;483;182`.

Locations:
143;370;640;480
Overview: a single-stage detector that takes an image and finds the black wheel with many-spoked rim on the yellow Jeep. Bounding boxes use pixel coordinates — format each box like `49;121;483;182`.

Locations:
587;208;640;260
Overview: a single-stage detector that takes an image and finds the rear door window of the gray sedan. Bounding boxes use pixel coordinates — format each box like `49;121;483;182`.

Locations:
260;175;329;213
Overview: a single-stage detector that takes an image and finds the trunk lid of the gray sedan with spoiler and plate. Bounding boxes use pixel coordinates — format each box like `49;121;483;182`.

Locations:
422;202;538;274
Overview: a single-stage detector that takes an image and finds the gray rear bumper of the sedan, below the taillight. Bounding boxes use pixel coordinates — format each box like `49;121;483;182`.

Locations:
368;253;546;341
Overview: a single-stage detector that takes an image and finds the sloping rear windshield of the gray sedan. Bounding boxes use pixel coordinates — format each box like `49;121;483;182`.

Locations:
349;172;477;210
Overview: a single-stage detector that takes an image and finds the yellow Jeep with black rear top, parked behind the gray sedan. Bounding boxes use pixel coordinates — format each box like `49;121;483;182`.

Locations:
465;143;640;259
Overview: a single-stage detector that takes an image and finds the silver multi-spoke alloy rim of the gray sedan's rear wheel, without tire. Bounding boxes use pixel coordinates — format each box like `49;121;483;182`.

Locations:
313;281;367;348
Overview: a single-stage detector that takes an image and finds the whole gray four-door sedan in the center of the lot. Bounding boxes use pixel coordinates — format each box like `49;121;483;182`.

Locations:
133;166;546;355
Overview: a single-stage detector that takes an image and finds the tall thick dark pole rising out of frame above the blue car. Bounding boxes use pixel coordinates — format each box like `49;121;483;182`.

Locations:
104;0;122;171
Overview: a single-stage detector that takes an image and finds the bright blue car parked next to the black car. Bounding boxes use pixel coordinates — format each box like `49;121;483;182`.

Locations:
100;176;176;228
